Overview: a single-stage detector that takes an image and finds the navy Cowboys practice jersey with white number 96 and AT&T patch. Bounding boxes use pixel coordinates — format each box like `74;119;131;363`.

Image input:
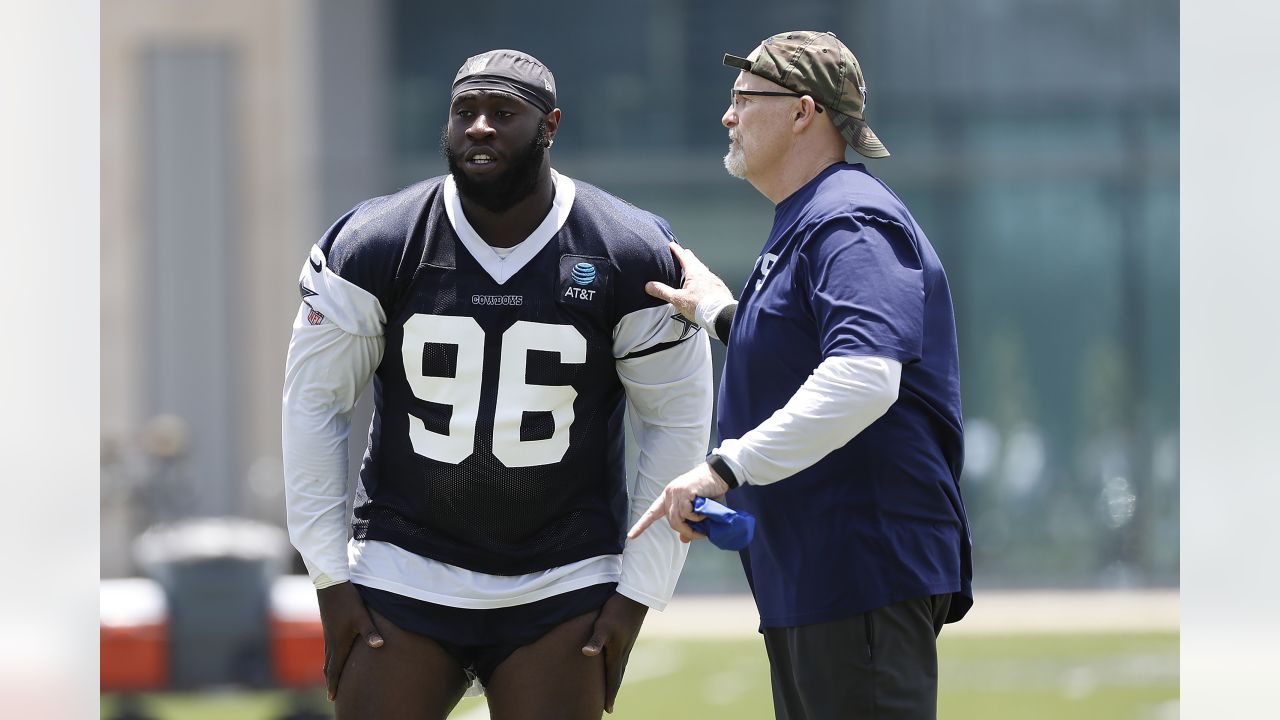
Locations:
302;176;696;575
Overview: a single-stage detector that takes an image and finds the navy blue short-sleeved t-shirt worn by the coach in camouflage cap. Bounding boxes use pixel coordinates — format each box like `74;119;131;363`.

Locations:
717;163;973;626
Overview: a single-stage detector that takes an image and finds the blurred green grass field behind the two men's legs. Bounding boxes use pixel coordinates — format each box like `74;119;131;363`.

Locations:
102;633;1178;720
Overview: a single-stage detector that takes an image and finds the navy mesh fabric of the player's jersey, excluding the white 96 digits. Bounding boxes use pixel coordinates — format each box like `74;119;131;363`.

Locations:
320;178;678;575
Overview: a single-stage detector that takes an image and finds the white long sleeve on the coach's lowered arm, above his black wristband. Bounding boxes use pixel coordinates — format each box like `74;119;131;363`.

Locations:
716;356;902;486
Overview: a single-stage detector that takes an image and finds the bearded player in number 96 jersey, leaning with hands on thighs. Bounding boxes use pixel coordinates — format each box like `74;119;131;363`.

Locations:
283;50;712;720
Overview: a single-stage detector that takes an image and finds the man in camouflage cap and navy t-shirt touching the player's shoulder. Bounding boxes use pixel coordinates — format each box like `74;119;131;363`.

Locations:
631;32;973;720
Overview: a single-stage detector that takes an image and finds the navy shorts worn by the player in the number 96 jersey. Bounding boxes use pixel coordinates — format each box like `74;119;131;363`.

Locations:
356;583;617;685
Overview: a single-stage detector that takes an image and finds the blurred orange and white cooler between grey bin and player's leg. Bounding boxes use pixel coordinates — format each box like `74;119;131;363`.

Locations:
269;575;324;688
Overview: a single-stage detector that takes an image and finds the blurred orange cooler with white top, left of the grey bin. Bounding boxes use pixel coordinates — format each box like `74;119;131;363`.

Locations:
99;578;169;693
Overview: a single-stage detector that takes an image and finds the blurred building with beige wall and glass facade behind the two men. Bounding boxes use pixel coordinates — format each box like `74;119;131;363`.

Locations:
101;0;1179;592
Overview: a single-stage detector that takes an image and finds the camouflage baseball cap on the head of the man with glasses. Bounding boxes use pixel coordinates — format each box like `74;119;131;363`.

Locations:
724;29;888;158
